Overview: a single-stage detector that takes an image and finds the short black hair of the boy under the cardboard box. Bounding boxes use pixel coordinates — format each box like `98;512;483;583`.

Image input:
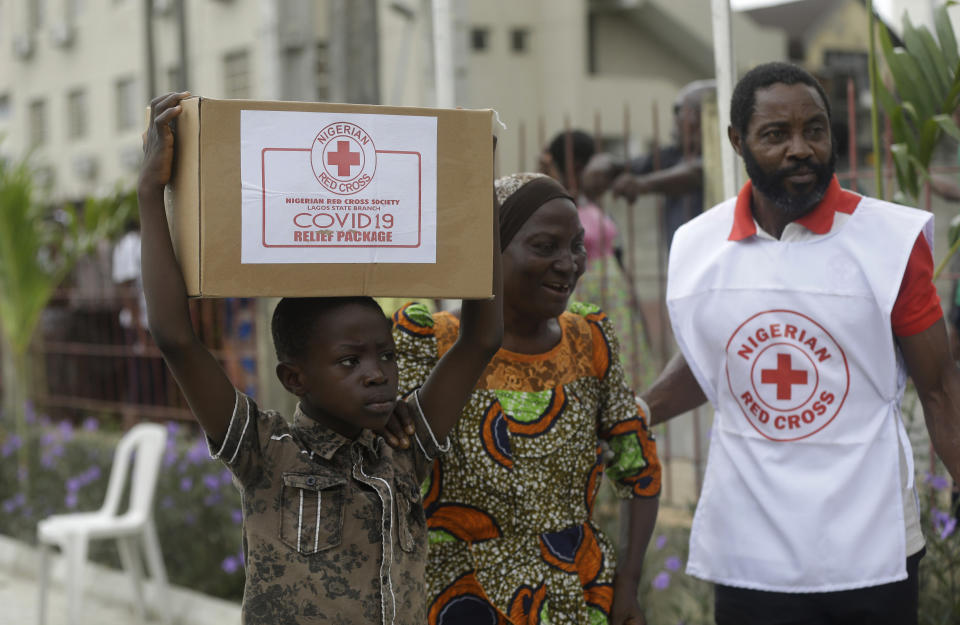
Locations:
270;296;389;362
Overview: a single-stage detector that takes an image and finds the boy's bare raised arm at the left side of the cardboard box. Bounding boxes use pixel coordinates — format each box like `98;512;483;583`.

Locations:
137;92;236;442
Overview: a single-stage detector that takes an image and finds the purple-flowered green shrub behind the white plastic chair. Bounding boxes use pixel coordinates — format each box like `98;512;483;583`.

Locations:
0;409;244;600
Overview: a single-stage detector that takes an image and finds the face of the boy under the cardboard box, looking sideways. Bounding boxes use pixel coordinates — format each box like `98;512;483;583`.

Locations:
277;304;397;438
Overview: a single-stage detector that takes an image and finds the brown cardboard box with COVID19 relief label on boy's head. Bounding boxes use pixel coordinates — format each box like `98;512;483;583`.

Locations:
170;98;493;298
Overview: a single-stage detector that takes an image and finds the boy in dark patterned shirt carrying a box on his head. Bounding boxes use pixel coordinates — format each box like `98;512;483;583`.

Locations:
138;92;503;625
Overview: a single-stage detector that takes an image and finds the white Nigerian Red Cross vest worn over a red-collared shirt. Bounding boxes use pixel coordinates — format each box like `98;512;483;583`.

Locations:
667;198;933;592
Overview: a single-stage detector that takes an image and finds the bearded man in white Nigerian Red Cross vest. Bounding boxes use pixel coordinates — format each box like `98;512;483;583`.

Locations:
644;63;960;625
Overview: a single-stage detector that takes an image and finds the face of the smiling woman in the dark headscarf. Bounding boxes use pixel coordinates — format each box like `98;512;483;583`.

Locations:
503;198;587;321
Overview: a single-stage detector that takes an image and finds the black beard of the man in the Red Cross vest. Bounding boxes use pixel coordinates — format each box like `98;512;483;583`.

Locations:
743;142;837;220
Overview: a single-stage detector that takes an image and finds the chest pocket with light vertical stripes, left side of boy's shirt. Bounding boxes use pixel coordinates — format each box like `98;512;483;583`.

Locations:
280;473;347;555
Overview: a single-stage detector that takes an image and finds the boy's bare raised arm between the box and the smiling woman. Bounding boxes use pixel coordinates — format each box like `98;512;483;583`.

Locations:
420;176;503;439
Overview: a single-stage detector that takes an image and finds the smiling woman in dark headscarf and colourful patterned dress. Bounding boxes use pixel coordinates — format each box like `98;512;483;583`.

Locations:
392;174;660;625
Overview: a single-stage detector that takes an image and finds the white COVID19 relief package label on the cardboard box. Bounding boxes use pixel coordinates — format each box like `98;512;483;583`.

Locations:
240;110;437;263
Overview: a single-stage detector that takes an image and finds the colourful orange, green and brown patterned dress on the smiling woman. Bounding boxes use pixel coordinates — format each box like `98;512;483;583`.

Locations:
394;304;660;625
